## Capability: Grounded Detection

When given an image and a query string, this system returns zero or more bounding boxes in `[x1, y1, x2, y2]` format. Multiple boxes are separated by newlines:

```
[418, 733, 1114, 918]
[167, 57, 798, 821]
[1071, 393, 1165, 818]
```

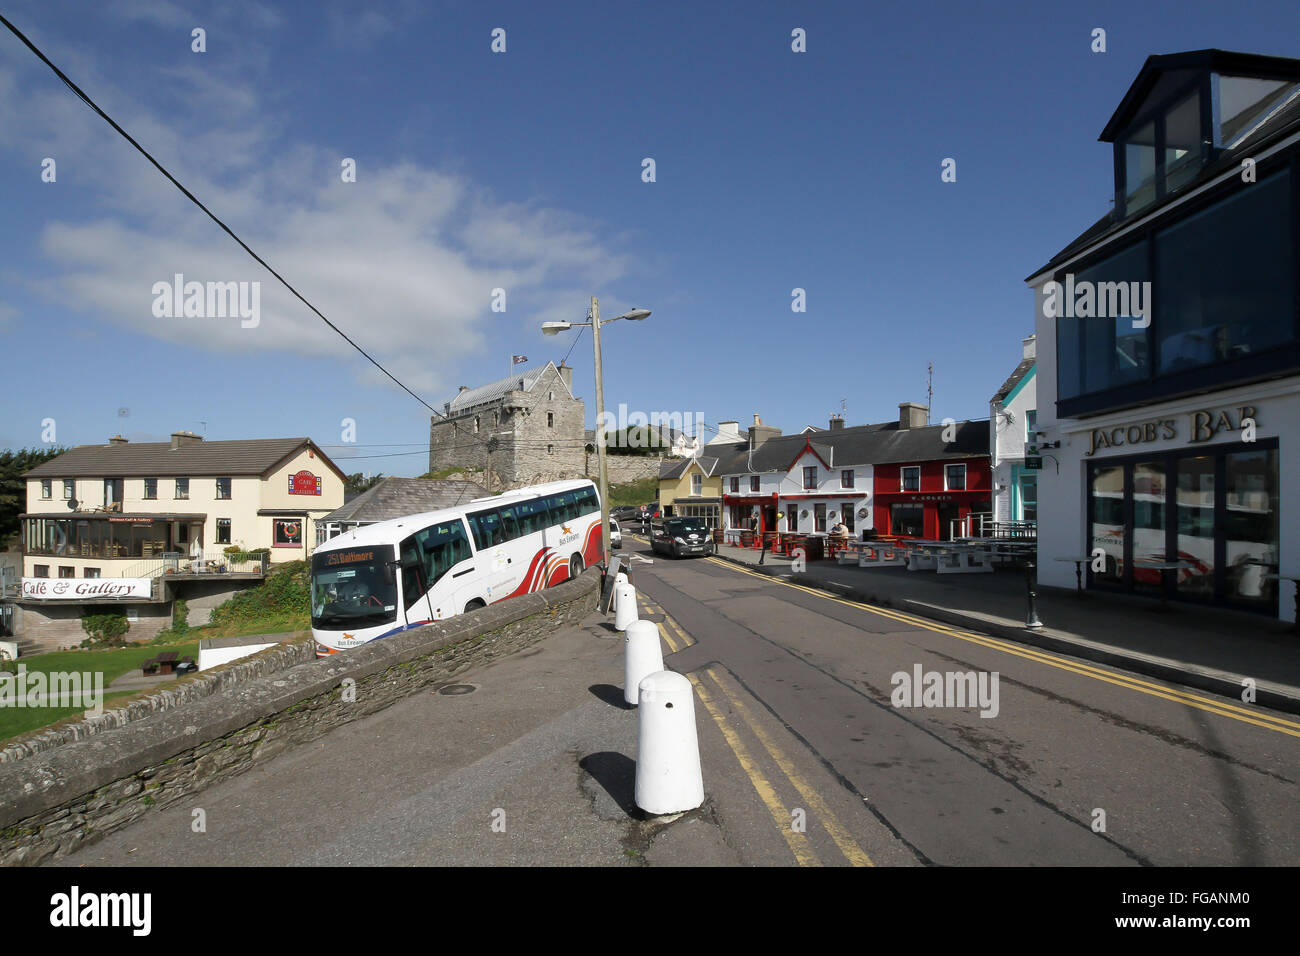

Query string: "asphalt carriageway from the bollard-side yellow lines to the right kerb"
[628, 540, 1300, 866]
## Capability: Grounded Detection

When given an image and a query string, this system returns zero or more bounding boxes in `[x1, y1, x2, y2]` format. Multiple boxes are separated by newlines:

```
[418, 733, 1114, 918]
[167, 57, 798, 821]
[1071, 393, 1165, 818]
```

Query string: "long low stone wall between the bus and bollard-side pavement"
[0, 570, 601, 865]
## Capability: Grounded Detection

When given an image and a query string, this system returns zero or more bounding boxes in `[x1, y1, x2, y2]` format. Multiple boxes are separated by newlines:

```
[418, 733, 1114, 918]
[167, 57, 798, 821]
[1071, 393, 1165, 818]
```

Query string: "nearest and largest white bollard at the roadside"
[636, 671, 705, 814]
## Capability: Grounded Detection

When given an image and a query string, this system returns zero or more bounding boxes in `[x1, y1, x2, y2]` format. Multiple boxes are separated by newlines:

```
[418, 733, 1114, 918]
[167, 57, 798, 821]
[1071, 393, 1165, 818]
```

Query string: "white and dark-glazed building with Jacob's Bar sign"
[1027, 49, 1300, 620]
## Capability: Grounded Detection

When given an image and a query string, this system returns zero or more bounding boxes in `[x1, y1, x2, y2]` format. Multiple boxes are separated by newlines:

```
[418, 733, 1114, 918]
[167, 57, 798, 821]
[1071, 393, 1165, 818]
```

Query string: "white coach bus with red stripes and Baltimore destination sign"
[311, 481, 601, 657]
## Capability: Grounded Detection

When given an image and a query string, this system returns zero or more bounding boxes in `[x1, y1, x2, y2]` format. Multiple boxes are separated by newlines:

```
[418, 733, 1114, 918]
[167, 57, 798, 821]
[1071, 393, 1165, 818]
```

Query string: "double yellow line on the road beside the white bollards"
[641, 598, 872, 866]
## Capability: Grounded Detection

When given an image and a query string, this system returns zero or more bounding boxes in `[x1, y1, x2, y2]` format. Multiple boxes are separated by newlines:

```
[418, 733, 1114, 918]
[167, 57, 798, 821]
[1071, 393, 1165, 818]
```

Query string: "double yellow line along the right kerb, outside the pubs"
[705, 558, 1300, 737]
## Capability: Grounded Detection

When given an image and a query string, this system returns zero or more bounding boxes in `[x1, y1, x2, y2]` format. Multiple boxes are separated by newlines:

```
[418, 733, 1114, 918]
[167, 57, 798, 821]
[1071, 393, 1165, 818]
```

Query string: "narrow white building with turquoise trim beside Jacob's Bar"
[988, 336, 1039, 522]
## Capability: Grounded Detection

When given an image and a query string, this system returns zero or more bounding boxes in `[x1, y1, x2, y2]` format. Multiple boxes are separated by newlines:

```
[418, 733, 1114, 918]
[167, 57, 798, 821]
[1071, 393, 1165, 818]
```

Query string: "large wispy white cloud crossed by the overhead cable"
[0, 42, 625, 395]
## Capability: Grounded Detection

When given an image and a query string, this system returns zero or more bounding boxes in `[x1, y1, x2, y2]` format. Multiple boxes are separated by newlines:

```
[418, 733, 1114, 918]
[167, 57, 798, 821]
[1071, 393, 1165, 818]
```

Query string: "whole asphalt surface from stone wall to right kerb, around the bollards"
[50, 537, 1300, 866]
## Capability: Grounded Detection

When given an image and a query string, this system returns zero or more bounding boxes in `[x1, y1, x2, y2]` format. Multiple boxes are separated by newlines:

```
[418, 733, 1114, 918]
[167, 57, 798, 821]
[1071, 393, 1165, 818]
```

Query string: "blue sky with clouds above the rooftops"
[0, 0, 1300, 475]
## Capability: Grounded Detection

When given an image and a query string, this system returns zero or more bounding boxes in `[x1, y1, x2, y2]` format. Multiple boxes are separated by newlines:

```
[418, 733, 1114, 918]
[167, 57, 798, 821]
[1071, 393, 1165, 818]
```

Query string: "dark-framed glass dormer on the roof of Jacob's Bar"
[1101, 49, 1300, 219]
